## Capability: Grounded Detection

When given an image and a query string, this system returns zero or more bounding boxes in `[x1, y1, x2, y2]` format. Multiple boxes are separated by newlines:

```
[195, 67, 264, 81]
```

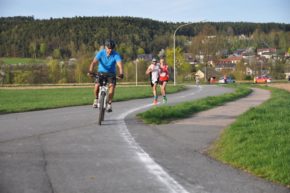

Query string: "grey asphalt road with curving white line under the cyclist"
[0, 86, 289, 193]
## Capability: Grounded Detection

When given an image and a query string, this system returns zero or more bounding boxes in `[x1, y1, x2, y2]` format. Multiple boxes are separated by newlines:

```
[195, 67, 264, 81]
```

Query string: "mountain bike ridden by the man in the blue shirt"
[91, 73, 115, 125]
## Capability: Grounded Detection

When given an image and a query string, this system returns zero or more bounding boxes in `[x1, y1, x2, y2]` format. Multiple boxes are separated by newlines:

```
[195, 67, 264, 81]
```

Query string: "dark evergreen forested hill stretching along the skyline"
[0, 17, 290, 58]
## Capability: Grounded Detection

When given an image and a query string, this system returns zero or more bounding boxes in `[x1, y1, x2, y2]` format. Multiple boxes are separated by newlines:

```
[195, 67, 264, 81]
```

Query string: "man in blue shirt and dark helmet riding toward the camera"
[89, 40, 124, 112]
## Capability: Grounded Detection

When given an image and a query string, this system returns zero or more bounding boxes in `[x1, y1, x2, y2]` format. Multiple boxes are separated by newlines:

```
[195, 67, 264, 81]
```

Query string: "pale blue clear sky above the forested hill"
[0, 0, 290, 24]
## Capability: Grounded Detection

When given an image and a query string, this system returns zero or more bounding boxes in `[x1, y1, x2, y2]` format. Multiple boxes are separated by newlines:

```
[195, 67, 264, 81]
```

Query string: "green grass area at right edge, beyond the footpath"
[209, 88, 290, 187]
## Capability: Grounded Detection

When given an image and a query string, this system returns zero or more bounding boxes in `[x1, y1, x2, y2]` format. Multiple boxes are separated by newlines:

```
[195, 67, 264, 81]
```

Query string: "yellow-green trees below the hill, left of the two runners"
[0, 57, 154, 84]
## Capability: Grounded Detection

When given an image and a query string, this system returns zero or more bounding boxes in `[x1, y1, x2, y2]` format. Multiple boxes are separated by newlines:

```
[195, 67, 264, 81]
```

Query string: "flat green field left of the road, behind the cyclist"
[0, 85, 185, 114]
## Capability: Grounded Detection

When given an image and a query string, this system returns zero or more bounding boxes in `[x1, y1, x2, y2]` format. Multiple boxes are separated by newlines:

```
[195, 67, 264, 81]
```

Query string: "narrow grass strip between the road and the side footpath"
[137, 85, 252, 124]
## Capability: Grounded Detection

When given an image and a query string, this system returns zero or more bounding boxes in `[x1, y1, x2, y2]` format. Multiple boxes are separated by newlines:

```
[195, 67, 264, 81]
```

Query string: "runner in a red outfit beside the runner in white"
[159, 57, 169, 103]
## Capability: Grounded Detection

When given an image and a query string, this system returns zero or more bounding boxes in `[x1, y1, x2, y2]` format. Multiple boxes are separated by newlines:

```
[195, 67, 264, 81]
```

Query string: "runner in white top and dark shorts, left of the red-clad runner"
[146, 58, 160, 105]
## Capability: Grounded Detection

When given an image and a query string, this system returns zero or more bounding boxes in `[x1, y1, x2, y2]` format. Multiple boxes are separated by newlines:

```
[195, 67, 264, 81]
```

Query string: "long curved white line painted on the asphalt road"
[118, 86, 206, 193]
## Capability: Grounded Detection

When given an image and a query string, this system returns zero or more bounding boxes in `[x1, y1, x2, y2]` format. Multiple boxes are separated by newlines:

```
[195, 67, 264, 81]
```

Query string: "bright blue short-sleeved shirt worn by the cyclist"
[96, 49, 122, 74]
